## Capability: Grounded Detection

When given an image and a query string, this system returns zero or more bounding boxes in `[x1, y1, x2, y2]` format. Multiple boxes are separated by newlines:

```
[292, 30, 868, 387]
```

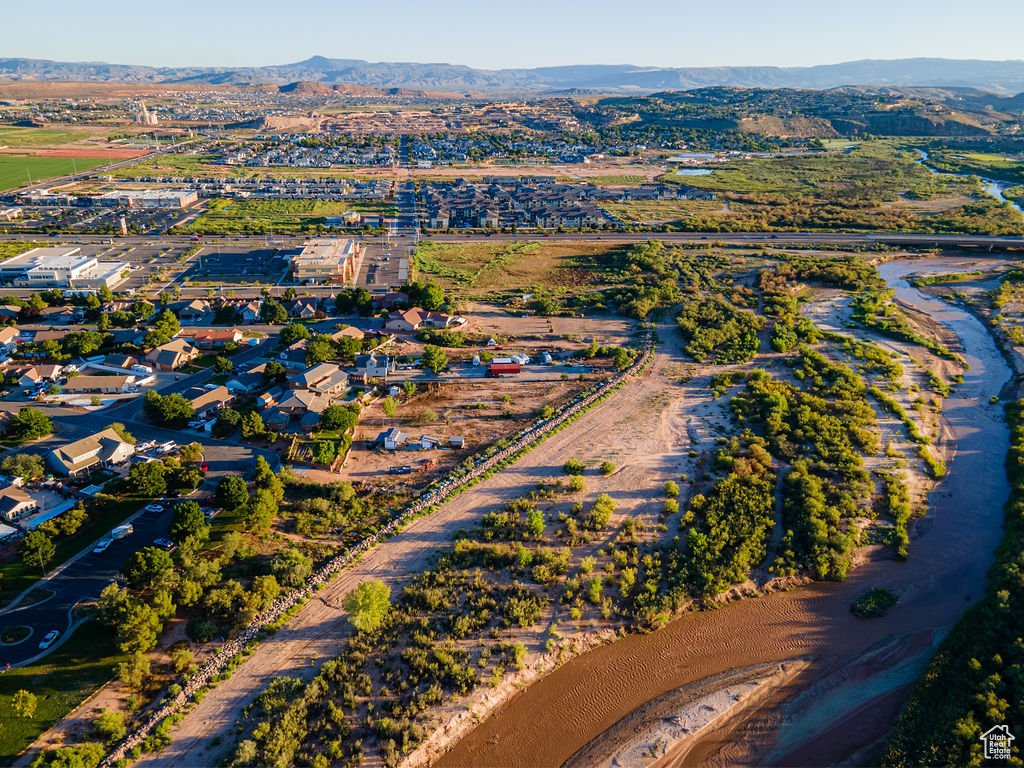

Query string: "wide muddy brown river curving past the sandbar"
[438, 259, 1011, 768]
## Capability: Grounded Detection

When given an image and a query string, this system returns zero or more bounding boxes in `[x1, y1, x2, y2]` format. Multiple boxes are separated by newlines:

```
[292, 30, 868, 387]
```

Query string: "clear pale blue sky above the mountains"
[8, 0, 1024, 69]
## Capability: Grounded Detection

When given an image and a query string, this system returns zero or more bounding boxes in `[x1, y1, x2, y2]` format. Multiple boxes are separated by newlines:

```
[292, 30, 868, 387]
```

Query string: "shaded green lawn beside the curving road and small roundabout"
[0, 621, 124, 765]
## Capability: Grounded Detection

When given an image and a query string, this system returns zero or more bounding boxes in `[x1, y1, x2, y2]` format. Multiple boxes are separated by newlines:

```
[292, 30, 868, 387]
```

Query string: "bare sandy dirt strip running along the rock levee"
[130, 315, 688, 768]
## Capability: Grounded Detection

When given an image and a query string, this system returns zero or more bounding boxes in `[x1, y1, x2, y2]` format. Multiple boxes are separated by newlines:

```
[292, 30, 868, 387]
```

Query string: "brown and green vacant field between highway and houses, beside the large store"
[414, 241, 622, 298]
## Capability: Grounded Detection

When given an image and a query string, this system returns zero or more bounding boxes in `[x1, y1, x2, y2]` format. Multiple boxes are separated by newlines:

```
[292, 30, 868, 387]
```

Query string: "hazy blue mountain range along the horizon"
[0, 56, 1024, 94]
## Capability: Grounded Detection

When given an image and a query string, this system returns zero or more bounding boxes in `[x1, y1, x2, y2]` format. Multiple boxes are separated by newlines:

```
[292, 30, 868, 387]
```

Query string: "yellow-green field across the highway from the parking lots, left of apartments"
[184, 200, 394, 234]
